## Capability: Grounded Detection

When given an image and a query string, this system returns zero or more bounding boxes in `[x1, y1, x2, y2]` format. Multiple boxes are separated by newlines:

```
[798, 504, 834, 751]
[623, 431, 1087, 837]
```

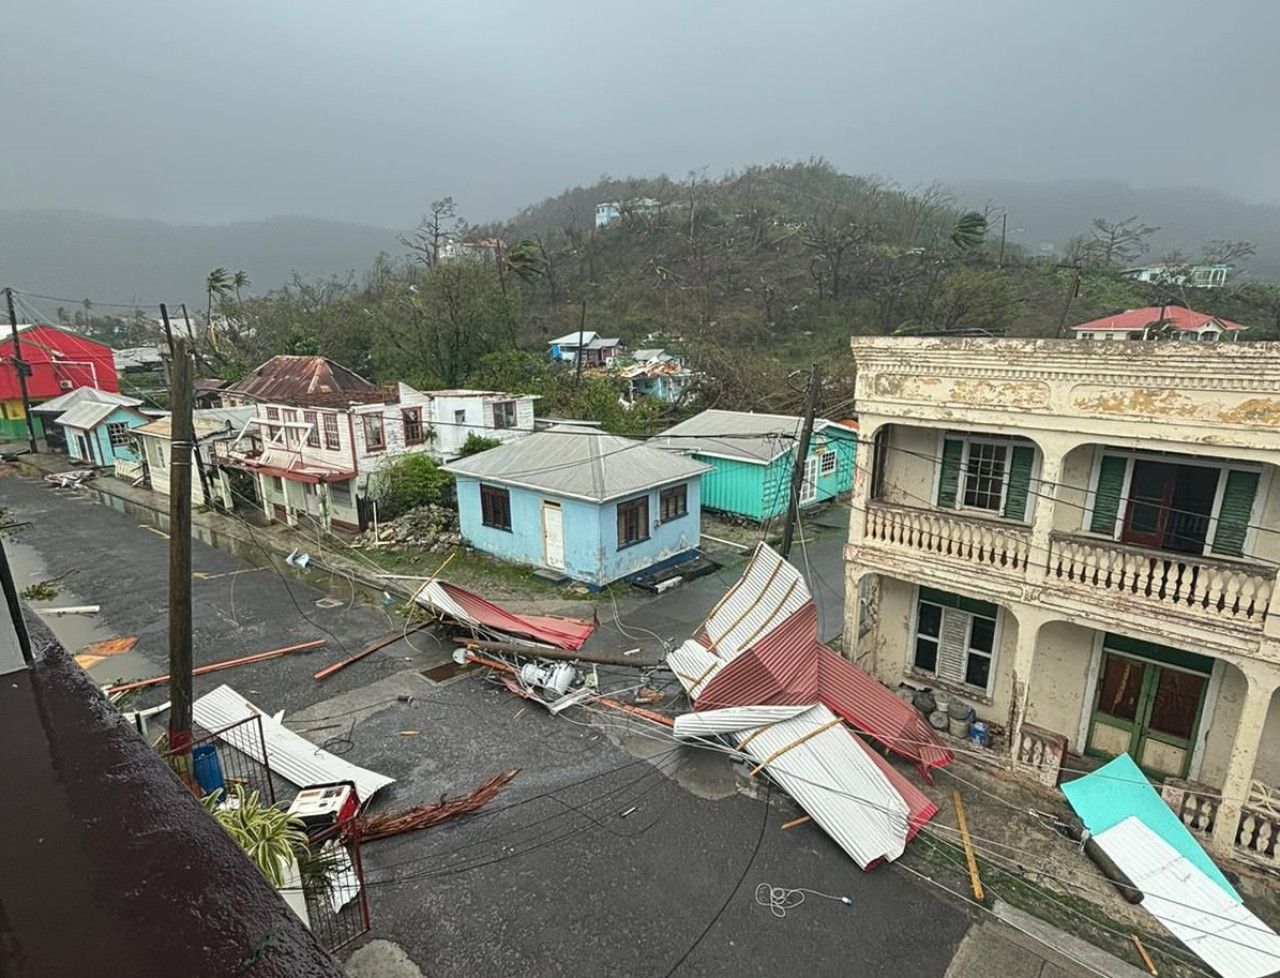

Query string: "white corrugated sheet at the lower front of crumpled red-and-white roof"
[677, 704, 911, 869]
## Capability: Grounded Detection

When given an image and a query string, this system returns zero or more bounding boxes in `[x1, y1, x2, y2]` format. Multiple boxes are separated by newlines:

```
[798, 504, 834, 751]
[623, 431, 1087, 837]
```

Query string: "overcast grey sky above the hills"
[0, 0, 1280, 227]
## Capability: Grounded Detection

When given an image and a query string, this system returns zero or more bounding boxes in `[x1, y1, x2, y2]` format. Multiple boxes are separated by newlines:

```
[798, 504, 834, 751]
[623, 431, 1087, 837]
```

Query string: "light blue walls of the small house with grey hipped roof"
[457, 477, 701, 586]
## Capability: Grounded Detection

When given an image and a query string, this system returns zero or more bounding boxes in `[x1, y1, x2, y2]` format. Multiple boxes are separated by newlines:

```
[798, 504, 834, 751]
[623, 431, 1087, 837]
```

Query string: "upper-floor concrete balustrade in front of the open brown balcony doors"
[1047, 534, 1276, 630]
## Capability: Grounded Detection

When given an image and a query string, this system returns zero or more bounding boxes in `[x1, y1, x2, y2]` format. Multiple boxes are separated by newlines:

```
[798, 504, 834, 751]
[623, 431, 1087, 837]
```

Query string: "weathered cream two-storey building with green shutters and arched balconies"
[845, 337, 1280, 869]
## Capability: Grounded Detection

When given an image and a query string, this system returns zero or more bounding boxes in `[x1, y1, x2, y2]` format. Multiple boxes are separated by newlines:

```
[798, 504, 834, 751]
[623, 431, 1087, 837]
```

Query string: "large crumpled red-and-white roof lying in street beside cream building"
[667, 544, 952, 869]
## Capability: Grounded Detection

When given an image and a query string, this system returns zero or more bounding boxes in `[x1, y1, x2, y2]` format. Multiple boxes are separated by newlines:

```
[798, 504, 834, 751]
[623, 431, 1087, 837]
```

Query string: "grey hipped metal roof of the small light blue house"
[444, 425, 710, 503]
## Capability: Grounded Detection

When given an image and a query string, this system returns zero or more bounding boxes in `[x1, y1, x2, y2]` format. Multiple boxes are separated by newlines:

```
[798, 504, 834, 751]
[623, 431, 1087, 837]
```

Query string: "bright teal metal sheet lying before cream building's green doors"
[1062, 754, 1242, 902]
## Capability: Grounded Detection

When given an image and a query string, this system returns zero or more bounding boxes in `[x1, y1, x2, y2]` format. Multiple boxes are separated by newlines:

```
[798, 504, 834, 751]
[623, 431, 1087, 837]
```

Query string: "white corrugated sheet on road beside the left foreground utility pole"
[191, 686, 396, 803]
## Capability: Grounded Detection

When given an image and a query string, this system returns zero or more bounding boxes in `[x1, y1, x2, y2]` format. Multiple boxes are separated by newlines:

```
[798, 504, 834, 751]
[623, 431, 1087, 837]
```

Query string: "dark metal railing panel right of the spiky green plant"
[302, 826, 371, 954]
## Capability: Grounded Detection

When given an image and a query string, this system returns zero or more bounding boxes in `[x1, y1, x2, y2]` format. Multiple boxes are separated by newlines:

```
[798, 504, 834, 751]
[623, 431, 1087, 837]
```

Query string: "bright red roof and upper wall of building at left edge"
[0, 325, 120, 401]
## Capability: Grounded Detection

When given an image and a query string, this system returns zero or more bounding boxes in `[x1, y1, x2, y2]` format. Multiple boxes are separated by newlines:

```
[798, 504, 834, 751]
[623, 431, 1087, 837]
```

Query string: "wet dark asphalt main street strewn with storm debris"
[0, 475, 968, 978]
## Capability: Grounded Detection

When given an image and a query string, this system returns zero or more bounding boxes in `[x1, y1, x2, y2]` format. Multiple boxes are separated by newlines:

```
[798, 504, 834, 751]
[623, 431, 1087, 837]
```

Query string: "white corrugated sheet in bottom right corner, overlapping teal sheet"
[1096, 815, 1280, 978]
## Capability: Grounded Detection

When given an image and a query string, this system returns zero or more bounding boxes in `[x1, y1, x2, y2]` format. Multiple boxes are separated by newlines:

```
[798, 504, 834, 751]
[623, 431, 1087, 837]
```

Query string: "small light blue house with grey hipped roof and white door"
[444, 425, 710, 588]
